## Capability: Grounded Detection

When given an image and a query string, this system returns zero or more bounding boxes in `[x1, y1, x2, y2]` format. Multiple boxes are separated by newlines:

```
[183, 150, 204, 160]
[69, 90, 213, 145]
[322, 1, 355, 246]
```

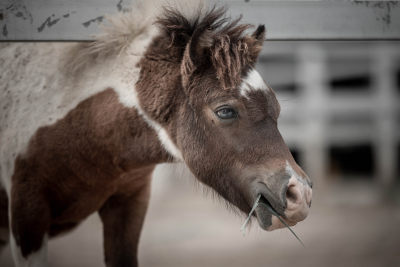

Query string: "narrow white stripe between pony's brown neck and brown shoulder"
[114, 85, 183, 161]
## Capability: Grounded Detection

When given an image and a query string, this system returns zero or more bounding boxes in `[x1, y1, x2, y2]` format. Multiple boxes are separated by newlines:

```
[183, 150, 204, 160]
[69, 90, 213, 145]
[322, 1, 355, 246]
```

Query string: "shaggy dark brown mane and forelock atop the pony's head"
[156, 6, 264, 88]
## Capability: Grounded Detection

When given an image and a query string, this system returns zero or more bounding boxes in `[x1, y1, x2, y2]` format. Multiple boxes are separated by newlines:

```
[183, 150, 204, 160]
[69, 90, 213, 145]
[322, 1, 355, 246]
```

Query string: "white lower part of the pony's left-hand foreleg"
[10, 234, 48, 267]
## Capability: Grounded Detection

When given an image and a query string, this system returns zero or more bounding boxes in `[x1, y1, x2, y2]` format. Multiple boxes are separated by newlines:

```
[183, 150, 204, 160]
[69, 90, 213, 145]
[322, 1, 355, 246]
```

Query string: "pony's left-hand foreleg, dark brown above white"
[10, 184, 50, 267]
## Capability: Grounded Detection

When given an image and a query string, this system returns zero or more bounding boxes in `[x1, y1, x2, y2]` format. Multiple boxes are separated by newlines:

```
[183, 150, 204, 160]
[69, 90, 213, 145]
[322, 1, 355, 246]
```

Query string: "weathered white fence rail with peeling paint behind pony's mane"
[0, 0, 400, 41]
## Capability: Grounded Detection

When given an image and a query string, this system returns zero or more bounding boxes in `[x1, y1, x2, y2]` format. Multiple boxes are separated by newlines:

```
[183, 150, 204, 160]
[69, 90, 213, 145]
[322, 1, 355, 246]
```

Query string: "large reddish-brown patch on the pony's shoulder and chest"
[11, 89, 168, 256]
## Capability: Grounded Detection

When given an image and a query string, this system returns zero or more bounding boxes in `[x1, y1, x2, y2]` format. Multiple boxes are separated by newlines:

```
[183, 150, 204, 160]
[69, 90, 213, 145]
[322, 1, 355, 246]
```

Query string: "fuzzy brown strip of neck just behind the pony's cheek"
[135, 34, 185, 160]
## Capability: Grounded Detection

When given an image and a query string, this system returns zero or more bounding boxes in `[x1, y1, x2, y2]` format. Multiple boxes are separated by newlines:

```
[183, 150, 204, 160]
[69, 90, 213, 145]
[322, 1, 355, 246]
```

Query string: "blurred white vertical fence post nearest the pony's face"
[295, 44, 328, 191]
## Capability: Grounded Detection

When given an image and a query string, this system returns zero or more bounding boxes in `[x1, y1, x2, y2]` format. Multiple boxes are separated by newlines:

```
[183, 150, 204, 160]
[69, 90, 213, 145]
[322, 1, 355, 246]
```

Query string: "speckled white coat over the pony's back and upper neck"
[0, 25, 164, 196]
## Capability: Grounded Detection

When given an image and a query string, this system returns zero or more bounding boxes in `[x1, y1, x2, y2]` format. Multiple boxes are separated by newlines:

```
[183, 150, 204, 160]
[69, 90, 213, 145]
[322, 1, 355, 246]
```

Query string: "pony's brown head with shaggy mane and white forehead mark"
[138, 8, 312, 230]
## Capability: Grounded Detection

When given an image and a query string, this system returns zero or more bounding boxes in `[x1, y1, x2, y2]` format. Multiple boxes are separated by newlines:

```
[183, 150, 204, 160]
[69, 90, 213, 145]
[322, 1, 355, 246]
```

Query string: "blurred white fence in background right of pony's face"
[258, 42, 400, 184]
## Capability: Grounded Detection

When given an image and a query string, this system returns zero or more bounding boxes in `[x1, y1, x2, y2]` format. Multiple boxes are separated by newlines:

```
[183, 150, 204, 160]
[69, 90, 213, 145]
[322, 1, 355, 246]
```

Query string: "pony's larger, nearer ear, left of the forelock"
[181, 29, 213, 88]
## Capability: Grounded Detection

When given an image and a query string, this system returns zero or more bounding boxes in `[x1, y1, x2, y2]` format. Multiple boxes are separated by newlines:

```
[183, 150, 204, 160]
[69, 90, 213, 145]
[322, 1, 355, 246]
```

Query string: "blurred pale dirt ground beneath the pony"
[0, 166, 400, 267]
